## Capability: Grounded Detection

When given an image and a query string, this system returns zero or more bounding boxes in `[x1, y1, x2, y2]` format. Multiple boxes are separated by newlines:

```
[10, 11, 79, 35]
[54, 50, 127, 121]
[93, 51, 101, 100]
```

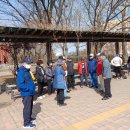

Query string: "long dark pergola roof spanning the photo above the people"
[0, 26, 130, 43]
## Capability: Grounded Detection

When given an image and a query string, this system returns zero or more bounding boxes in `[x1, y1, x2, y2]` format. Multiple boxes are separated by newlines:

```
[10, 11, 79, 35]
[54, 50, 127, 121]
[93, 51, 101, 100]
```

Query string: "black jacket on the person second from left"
[35, 65, 45, 82]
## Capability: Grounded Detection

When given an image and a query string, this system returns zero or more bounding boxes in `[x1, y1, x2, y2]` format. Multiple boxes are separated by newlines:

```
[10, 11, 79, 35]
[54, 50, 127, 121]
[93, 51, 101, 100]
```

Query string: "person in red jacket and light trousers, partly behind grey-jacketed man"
[97, 53, 105, 94]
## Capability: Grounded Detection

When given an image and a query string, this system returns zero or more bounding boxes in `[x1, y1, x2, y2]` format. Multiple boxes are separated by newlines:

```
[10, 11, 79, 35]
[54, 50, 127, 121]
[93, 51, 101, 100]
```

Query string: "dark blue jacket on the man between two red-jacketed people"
[88, 58, 98, 74]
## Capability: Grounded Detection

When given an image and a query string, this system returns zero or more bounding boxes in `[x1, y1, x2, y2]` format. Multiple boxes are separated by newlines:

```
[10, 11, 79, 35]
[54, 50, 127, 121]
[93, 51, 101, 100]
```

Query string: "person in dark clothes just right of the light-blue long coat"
[66, 57, 76, 92]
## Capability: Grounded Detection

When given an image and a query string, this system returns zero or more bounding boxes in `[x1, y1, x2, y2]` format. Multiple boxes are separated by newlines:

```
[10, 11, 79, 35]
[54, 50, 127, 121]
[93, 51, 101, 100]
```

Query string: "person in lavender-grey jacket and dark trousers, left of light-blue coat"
[45, 61, 54, 95]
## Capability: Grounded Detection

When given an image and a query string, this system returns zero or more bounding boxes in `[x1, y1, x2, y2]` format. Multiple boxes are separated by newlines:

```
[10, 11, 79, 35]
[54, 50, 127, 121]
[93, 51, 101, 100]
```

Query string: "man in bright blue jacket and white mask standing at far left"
[17, 57, 36, 128]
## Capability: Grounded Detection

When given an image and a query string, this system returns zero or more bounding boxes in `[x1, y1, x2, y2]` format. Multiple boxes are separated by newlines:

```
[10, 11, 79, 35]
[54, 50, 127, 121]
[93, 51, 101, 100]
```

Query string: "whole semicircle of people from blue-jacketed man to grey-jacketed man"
[17, 52, 112, 128]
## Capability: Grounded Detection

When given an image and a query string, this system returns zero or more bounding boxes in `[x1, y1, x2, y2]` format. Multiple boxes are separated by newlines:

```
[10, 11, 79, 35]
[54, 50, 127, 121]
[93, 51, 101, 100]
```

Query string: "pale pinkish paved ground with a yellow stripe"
[0, 77, 130, 130]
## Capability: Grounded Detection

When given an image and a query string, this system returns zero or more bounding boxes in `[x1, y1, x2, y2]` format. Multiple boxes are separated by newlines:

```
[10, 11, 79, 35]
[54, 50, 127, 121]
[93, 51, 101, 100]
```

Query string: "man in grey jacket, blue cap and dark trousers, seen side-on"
[100, 52, 112, 100]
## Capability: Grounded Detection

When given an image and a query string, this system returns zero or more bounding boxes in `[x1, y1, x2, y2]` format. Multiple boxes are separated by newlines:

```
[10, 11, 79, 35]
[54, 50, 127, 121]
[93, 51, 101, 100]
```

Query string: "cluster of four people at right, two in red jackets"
[78, 53, 112, 100]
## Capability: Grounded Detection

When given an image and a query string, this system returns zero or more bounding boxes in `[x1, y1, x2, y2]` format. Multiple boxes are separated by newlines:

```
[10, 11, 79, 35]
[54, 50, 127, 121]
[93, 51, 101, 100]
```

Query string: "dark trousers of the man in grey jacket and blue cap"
[104, 78, 112, 97]
